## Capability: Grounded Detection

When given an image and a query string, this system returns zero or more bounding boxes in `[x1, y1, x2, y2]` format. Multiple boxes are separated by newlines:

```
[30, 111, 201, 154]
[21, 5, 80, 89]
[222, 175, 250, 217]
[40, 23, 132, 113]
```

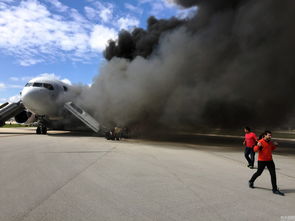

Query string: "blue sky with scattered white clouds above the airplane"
[0, 0, 198, 103]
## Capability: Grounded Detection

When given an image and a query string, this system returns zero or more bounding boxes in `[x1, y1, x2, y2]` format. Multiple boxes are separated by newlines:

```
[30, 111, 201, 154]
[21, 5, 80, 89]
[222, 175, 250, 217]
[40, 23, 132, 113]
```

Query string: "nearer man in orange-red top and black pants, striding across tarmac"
[249, 131, 285, 196]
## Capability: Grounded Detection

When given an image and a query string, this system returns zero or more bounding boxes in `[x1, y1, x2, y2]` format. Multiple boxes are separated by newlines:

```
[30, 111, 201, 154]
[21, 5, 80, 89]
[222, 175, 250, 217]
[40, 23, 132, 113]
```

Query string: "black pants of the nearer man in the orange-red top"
[249, 161, 278, 190]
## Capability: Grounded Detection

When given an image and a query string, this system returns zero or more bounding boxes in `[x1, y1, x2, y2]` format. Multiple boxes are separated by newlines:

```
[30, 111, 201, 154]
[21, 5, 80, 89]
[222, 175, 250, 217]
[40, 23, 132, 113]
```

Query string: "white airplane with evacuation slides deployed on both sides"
[0, 77, 101, 134]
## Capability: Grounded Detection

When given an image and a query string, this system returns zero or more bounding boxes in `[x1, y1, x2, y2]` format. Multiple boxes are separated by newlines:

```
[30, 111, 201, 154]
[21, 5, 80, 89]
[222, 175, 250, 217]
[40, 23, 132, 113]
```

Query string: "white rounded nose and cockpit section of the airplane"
[21, 77, 70, 117]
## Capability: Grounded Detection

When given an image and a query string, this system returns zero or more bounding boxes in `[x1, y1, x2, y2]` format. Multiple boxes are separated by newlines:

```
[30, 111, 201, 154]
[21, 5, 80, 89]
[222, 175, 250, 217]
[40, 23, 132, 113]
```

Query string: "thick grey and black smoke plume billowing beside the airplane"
[80, 0, 295, 128]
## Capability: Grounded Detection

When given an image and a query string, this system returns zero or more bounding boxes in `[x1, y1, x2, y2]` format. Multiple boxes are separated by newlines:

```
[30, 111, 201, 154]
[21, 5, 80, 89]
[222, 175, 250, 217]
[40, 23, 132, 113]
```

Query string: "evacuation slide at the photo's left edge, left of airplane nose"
[0, 101, 25, 126]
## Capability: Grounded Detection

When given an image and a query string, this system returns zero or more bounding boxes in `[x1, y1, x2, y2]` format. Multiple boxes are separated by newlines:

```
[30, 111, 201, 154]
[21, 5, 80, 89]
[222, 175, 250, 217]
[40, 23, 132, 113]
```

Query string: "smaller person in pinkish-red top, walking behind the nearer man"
[243, 127, 257, 169]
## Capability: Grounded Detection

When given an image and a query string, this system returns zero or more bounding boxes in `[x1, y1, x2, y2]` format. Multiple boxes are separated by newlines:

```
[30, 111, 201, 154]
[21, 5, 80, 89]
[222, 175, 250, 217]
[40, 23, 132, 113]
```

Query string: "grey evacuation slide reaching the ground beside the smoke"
[64, 101, 100, 133]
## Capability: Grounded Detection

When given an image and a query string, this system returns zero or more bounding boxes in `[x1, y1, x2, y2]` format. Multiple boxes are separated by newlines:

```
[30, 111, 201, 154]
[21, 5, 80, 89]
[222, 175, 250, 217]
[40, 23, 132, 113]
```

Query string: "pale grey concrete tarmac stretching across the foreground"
[0, 128, 295, 221]
